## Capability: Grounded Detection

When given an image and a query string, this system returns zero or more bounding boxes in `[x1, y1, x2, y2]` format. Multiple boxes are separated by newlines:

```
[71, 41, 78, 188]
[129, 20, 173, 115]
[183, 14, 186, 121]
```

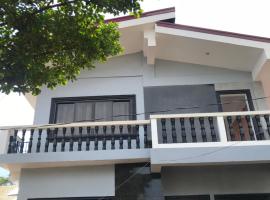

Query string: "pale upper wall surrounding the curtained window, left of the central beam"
[34, 54, 144, 124]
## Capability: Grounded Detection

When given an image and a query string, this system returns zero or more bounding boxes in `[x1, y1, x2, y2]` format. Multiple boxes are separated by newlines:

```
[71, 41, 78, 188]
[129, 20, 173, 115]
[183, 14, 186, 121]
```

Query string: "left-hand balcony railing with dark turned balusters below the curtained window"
[1, 120, 151, 154]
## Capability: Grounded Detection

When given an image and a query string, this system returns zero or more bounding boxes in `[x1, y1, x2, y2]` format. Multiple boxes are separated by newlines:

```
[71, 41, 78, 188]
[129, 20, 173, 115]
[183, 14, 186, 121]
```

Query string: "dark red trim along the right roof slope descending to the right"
[157, 22, 270, 43]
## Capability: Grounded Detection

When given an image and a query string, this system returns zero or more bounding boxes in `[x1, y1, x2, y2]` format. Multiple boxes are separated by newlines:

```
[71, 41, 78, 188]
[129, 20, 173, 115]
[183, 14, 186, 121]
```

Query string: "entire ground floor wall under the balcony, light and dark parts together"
[18, 163, 270, 200]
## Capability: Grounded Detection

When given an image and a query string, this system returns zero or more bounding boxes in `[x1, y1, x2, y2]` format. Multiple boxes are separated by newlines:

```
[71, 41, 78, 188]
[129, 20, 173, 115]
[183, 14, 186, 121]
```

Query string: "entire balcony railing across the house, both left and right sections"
[0, 111, 270, 154]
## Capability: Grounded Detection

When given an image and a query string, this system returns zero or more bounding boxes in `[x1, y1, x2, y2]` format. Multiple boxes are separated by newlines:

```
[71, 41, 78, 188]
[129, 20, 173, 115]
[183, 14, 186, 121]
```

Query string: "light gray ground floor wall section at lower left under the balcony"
[18, 165, 115, 200]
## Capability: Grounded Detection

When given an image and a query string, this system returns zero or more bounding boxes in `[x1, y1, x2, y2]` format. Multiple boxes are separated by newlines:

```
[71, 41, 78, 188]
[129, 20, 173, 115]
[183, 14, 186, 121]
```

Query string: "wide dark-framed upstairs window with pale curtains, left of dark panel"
[50, 95, 136, 123]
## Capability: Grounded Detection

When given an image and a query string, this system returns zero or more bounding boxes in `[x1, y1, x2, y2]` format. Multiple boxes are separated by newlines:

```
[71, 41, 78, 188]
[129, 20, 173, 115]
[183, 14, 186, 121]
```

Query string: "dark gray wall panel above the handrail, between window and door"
[144, 85, 218, 117]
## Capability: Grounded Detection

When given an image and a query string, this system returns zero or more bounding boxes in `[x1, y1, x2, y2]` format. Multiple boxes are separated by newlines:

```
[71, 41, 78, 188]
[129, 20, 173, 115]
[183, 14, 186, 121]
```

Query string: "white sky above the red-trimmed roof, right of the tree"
[142, 0, 270, 37]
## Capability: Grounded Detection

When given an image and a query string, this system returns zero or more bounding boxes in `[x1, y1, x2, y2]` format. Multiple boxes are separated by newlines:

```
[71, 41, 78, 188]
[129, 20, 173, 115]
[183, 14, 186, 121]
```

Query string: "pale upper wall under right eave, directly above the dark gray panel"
[144, 60, 252, 86]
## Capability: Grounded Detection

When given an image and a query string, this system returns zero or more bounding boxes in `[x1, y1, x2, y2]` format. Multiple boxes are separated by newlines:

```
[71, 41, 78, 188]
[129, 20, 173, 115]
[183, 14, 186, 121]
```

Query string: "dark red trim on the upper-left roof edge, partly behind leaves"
[105, 7, 175, 22]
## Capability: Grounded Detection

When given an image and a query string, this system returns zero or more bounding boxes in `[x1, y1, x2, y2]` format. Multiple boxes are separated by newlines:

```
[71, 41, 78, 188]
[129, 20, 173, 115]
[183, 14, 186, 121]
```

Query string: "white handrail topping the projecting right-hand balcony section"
[150, 110, 270, 119]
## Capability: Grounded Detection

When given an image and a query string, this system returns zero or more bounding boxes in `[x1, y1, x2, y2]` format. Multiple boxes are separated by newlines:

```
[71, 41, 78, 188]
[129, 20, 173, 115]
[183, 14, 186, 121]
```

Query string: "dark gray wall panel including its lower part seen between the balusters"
[144, 85, 219, 143]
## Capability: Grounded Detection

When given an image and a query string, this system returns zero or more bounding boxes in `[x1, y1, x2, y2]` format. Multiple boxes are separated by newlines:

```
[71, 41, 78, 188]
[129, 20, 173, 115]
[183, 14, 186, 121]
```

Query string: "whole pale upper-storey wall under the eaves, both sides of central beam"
[34, 53, 266, 124]
